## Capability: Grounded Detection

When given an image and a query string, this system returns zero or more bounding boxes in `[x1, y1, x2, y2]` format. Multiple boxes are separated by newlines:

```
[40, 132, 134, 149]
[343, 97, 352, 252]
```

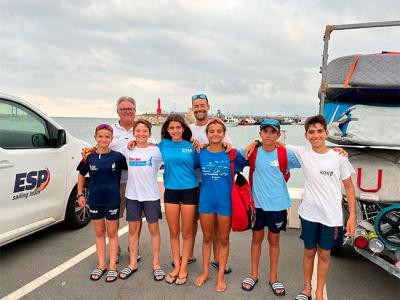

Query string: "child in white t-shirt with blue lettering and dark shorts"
[119, 120, 165, 281]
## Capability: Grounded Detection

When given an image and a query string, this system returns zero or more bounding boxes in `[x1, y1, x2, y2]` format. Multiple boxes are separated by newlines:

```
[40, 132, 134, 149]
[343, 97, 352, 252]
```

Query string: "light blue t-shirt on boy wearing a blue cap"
[241, 147, 300, 211]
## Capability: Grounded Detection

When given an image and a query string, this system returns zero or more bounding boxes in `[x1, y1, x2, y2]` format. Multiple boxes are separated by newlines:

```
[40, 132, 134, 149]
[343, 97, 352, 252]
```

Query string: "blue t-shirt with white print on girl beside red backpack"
[198, 148, 247, 212]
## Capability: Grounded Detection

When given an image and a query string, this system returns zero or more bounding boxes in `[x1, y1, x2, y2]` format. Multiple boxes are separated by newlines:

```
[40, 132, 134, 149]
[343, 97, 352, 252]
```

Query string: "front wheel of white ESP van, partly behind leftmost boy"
[65, 184, 90, 229]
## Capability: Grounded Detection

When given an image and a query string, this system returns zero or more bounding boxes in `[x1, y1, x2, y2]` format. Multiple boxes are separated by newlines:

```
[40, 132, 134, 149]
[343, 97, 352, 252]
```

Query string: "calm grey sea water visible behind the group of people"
[53, 117, 309, 188]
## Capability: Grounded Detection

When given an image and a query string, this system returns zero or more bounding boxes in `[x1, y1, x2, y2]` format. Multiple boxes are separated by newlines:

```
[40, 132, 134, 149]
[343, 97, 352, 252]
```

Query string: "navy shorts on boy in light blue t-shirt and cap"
[253, 208, 287, 233]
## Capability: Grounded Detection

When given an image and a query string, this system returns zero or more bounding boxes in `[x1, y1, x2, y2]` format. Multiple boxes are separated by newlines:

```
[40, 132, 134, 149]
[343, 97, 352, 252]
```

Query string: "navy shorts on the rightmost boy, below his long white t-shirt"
[300, 218, 343, 250]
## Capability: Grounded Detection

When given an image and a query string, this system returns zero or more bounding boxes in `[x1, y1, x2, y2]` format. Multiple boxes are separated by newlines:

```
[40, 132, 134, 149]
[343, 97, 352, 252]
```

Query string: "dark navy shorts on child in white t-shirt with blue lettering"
[126, 198, 162, 224]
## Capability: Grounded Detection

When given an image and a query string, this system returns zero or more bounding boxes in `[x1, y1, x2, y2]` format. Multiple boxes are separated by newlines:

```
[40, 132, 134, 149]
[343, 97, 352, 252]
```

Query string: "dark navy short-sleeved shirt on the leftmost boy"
[76, 150, 128, 207]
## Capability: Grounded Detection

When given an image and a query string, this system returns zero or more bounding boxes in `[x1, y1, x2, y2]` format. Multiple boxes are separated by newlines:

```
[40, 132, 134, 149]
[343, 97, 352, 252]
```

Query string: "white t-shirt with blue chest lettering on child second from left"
[119, 146, 163, 201]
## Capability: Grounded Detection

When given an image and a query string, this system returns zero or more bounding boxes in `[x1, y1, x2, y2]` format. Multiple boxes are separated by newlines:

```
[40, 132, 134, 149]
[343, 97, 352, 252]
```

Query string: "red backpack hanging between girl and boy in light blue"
[228, 149, 256, 231]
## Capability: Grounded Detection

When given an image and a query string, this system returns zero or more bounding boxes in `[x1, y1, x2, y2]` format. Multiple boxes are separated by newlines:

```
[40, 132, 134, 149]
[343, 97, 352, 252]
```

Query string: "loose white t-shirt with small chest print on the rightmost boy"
[286, 145, 355, 227]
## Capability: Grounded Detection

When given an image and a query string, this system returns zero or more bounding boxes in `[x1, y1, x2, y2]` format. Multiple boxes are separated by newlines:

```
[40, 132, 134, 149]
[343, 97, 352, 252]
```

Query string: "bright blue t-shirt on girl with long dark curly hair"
[157, 139, 198, 190]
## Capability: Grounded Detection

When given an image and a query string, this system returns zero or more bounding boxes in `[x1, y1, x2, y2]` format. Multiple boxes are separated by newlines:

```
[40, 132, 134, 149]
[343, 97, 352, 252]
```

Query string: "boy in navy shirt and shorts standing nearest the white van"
[77, 124, 127, 282]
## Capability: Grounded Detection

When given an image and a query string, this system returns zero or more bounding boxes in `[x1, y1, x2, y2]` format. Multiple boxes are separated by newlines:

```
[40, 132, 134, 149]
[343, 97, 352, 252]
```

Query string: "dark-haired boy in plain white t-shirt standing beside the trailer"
[286, 115, 356, 300]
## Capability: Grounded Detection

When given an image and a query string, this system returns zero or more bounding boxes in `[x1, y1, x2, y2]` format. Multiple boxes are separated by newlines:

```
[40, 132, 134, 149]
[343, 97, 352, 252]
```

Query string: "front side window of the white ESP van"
[0, 99, 50, 149]
